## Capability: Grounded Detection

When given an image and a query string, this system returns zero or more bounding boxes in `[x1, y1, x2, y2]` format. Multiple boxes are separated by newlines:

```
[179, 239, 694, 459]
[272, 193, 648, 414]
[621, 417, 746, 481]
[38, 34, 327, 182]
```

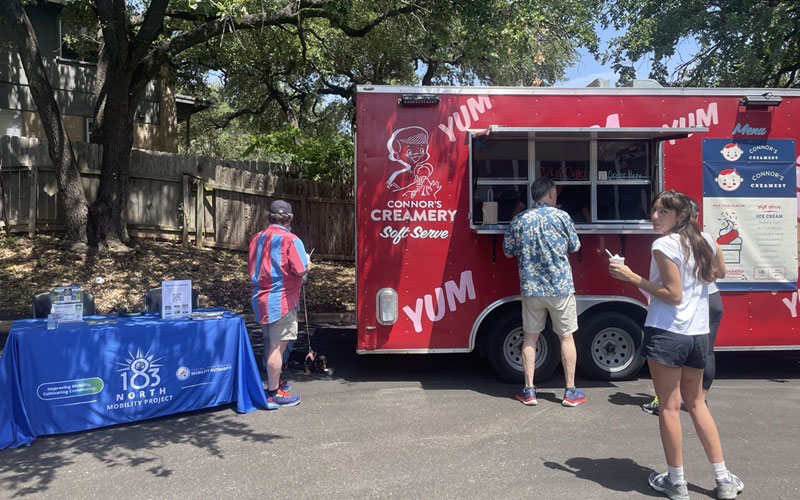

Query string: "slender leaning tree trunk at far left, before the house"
[0, 0, 87, 243]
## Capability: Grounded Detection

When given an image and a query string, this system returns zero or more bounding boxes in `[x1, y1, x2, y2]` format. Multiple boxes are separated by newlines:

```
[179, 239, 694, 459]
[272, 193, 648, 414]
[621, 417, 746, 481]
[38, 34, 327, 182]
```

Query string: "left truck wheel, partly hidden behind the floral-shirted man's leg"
[488, 314, 561, 383]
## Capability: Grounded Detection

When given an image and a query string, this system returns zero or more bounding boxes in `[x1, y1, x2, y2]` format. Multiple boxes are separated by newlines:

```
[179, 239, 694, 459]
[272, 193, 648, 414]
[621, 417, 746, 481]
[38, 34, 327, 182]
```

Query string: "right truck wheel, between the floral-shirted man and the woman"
[576, 312, 644, 380]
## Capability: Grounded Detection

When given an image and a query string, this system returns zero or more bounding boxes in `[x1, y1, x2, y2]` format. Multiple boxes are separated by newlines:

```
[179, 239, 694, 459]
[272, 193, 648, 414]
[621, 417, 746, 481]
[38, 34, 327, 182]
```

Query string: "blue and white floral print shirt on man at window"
[503, 202, 581, 297]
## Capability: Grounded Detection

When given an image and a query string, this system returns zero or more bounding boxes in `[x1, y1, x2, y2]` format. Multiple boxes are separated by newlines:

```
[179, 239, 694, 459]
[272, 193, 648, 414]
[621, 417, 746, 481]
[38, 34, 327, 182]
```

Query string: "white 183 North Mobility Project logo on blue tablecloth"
[106, 349, 172, 410]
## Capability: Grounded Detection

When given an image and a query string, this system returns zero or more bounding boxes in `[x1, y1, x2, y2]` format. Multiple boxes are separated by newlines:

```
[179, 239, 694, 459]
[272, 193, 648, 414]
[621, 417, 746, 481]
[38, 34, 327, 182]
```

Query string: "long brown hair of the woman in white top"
[651, 189, 714, 283]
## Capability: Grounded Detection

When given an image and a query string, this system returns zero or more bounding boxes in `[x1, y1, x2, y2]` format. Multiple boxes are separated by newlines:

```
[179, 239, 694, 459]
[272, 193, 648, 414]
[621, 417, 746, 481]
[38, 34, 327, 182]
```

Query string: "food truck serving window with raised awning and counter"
[470, 126, 708, 231]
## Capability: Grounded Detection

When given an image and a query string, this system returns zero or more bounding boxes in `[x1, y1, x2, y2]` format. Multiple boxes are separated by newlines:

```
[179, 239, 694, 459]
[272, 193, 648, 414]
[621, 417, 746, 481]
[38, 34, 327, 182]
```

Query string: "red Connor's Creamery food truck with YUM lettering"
[355, 81, 800, 382]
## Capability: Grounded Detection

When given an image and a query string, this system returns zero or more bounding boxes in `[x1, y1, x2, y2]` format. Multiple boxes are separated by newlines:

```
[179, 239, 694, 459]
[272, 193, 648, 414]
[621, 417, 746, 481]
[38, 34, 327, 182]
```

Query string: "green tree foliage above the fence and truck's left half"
[174, 0, 597, 179]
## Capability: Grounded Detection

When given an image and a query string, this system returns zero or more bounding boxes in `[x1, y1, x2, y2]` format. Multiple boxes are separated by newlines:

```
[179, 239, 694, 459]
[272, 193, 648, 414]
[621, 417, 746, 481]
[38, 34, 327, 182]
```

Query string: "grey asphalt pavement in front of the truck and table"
[0, 327, 800, 500]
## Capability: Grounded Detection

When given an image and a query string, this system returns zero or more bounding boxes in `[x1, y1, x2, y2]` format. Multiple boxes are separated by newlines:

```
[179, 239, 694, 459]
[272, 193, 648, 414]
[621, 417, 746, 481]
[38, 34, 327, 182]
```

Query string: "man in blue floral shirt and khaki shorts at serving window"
[503, 178, 586, 406]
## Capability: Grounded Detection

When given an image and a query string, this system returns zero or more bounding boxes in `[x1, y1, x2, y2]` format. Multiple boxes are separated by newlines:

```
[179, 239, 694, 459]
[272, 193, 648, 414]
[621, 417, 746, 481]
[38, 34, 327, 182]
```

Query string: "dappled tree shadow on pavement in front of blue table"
[0, 405, 282, 498]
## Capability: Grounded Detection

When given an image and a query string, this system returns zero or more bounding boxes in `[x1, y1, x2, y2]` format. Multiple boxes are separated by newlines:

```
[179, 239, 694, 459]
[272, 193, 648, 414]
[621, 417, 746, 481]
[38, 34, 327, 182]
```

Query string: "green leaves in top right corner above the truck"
[602, 0, 800, 87]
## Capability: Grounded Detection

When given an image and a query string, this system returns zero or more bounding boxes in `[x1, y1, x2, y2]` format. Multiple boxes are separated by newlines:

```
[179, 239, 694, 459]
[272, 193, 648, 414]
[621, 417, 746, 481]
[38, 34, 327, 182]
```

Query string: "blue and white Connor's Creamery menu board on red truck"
[703, 139, 797, 290]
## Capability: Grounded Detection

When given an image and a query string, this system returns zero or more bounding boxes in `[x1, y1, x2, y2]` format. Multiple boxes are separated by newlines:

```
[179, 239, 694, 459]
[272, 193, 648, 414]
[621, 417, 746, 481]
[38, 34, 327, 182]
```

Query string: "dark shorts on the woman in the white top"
[642, 326, 708, 369]
